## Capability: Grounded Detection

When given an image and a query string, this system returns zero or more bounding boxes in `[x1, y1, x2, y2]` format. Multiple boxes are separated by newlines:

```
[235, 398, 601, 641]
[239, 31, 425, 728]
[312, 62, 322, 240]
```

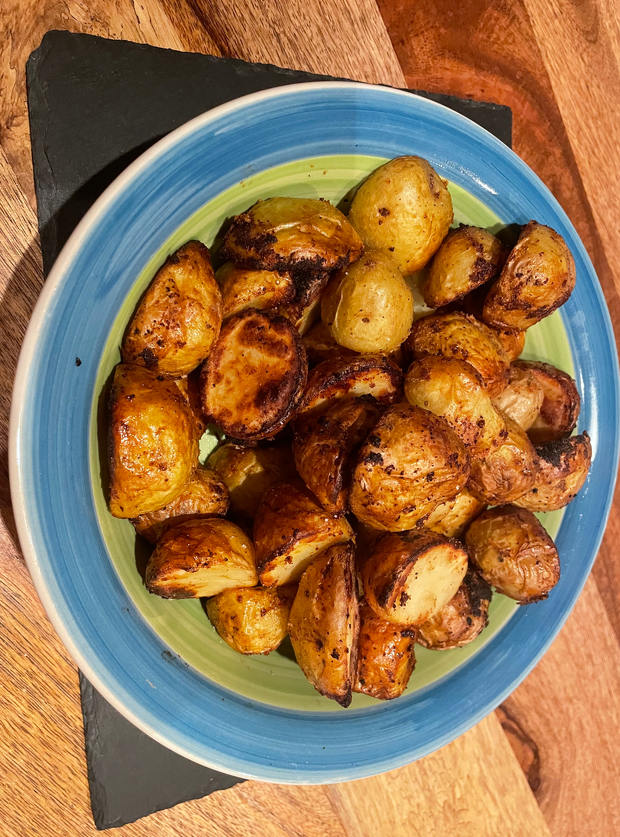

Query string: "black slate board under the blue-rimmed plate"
[27, 32, 512, 829]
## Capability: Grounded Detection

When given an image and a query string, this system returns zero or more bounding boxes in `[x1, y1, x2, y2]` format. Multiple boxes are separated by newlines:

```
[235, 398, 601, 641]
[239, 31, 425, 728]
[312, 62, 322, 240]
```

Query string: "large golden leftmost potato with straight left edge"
[108, 363, 198, 517]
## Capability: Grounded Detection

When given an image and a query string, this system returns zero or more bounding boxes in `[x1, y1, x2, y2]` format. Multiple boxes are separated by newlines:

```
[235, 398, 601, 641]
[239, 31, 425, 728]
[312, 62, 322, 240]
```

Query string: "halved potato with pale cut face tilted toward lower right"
[362, 529, 467, 626]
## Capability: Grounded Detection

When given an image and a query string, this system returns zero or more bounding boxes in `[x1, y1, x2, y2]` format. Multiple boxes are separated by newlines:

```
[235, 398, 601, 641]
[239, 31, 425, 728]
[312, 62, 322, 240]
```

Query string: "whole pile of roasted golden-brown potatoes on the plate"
[108, 157, 591, 706]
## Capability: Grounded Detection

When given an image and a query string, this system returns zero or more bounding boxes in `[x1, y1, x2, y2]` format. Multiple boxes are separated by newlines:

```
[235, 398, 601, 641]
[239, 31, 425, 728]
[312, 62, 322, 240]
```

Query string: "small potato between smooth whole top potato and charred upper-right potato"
[423, 224, 505, 308]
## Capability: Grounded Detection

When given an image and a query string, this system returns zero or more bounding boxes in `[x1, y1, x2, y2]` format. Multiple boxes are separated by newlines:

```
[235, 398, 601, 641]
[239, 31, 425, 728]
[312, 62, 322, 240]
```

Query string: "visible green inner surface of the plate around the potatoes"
[90, 155, 573, 712]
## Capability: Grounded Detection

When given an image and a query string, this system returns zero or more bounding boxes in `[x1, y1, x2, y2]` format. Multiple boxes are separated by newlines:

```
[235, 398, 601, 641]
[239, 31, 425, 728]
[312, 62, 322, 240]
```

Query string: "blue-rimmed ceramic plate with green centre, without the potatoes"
[10, 82, 620, 783]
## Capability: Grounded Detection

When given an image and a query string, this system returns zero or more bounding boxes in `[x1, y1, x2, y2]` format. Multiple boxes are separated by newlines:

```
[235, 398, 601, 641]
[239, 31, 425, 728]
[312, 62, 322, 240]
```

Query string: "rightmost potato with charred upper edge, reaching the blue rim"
[514, 433, 592, 511]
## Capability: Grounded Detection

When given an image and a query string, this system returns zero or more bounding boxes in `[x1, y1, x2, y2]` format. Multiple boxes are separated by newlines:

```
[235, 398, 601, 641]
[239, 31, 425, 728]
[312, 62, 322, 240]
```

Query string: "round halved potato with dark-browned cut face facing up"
[201, 309, 308, 440]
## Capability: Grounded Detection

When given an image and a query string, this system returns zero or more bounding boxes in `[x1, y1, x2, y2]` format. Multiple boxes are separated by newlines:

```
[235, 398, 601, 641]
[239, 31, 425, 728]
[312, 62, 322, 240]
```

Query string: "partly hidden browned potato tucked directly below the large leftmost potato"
[131, 468, 229, 543]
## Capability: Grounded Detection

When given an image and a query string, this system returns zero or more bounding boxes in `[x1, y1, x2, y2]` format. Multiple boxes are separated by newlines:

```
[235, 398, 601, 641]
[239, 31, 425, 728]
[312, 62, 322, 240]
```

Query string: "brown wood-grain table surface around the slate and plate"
[0, 0, 620, 837]
